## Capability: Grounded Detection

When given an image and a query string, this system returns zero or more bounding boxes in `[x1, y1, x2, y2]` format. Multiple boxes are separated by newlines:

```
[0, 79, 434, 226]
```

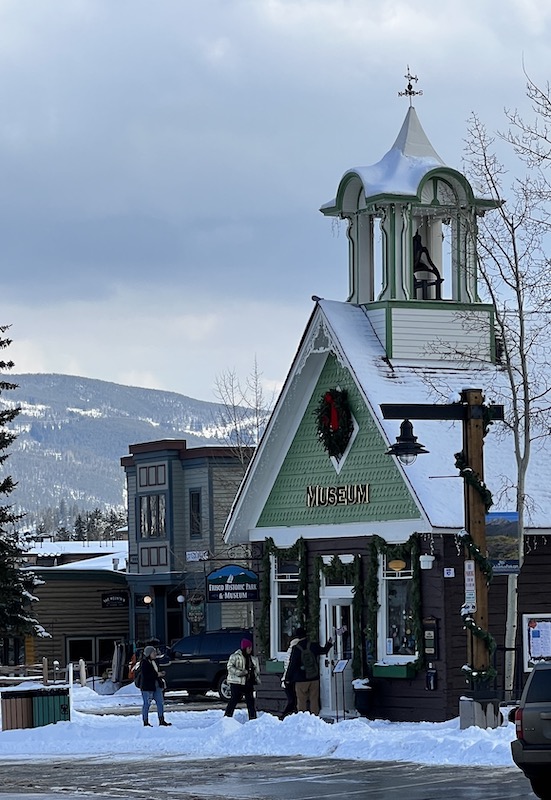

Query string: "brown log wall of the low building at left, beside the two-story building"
[33, 574, 129, 667]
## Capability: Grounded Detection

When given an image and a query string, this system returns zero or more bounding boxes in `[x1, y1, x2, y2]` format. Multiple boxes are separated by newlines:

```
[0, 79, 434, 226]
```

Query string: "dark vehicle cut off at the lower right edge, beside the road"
[511, 662, 551, 800]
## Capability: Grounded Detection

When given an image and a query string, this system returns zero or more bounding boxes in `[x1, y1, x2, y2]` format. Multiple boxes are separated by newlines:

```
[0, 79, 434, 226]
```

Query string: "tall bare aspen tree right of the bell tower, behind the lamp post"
[466, 82, 551, 692]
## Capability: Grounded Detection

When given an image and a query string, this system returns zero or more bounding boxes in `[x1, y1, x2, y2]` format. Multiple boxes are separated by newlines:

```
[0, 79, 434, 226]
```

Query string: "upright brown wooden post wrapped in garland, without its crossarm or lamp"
[462, 389, 490, 671]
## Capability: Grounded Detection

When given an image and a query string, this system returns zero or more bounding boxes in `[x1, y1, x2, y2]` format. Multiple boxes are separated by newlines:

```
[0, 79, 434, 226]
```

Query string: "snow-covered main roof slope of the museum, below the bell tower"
[319, 300, 551, 529]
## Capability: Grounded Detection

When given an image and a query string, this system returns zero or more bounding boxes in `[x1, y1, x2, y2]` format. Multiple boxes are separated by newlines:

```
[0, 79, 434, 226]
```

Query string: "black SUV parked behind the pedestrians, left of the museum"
[159, 628, 253, 700]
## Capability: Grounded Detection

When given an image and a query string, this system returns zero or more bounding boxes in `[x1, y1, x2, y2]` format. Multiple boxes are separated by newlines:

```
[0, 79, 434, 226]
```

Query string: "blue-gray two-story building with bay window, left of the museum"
[121, 439, 252, 644]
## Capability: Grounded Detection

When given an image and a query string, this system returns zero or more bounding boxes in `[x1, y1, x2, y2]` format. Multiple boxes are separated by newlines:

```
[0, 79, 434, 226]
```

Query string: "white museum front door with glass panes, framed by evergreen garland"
[320, 586, 354, 719]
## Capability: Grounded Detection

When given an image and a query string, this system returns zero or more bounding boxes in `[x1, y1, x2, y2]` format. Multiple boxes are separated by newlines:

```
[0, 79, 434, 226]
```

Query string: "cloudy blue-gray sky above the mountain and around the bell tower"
[4, 0, 551, 400]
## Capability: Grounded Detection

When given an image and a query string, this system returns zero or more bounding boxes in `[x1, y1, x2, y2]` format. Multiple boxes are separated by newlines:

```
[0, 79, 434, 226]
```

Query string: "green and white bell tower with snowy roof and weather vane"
[320, 72, 495, 362]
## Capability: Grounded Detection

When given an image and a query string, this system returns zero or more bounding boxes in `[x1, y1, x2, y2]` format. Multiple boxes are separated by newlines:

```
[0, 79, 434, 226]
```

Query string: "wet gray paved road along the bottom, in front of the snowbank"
[0, 754, 534, 800]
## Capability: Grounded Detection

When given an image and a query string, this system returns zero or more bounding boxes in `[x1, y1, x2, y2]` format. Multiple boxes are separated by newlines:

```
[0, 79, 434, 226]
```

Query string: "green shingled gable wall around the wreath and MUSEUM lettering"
[257, 355, 420, 528]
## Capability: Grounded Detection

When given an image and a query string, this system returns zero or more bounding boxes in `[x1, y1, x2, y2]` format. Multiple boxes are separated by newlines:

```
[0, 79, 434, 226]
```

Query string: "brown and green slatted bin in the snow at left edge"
[0, 686, 71, 731]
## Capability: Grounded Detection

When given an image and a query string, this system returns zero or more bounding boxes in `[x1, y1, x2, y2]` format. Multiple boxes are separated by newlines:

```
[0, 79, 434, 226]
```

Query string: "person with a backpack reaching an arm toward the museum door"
[285, 628, 333, 715]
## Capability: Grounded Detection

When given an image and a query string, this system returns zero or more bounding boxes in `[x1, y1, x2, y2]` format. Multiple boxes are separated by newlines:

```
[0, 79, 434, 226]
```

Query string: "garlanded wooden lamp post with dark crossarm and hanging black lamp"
[381, 389, 503, 672]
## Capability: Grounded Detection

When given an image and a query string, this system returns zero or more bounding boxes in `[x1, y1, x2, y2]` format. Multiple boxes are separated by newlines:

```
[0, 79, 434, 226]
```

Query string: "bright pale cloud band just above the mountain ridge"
[4, 287, 312, 400]
